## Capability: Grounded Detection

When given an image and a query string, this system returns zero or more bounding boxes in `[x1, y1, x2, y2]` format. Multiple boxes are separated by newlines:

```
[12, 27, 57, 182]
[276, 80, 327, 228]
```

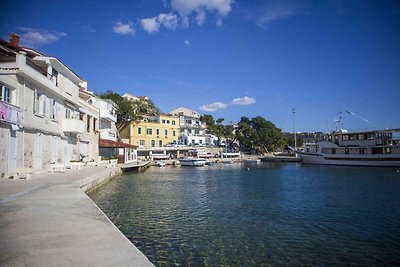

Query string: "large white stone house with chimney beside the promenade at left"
[0, 34, 96, 177]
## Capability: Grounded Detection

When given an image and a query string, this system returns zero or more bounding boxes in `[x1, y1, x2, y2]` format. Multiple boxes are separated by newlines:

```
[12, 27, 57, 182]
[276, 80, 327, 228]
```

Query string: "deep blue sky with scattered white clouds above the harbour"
[0, 0, 400, 132]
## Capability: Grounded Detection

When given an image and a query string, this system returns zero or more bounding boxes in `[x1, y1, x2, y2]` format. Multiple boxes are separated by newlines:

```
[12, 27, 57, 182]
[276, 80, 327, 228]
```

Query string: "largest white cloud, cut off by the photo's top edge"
[171, 0, 234, 27]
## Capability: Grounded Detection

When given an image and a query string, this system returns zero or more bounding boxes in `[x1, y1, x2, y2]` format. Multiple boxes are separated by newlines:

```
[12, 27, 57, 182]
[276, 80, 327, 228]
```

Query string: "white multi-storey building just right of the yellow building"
[169, 107, 214, 145]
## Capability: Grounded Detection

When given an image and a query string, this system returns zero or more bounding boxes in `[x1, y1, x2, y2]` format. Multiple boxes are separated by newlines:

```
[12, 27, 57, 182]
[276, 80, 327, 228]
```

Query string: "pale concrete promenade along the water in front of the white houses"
[0, 167, 153, 266]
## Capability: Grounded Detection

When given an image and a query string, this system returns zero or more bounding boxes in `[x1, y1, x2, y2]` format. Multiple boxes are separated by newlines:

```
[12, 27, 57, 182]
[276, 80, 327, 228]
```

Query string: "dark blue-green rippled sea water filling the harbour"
[90, 163, 400, 266]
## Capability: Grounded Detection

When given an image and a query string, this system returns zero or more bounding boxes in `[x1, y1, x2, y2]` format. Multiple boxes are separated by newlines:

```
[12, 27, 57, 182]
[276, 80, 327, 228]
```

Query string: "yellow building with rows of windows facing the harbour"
[120, 115, 179, 148]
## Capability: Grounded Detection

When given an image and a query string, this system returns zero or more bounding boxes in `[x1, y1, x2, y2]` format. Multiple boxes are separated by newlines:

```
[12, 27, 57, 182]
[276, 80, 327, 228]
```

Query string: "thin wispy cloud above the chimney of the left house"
[19, 27, 67, 48]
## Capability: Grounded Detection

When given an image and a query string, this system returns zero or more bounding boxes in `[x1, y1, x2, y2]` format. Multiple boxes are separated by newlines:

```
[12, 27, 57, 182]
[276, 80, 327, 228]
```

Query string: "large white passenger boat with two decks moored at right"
[296, 129, 400, 167]
